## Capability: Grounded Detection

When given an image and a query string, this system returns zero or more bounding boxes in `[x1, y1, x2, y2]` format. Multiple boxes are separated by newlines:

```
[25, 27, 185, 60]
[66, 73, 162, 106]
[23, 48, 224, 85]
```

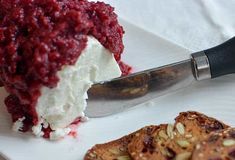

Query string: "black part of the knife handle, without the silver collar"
[204, 37, 235, 78]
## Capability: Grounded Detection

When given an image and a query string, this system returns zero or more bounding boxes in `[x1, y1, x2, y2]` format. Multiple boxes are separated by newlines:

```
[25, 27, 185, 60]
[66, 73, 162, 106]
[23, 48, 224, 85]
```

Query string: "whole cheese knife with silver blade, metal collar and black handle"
[85, 37, 235, 118]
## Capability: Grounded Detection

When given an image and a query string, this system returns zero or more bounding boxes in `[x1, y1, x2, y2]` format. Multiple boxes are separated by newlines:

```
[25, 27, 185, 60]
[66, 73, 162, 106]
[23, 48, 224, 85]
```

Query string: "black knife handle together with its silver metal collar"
[191, 37, 235, 80]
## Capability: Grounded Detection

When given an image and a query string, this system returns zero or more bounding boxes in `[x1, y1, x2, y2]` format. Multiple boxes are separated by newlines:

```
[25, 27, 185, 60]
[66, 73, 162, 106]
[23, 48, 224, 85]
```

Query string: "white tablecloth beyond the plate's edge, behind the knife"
[105, 0, 235, 51]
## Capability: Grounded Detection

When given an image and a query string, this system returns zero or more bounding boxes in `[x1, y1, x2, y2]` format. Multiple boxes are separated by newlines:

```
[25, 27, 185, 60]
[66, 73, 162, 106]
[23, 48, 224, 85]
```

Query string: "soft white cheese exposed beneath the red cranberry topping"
[33, 37, 121, 139]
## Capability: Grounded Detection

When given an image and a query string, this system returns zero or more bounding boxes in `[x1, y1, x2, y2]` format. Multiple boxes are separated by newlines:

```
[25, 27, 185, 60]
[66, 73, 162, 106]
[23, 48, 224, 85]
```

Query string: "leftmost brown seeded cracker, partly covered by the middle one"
[84, 129, 149, 160]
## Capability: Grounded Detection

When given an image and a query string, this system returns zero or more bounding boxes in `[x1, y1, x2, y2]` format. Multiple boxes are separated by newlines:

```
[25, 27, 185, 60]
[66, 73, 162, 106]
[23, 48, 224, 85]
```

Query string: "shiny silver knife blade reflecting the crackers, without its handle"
[85, 59, 196, 118]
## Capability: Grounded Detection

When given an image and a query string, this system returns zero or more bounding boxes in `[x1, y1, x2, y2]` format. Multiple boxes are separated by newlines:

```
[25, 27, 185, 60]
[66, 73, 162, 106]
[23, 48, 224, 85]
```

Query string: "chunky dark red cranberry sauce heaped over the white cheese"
[0, 0, 126, 131]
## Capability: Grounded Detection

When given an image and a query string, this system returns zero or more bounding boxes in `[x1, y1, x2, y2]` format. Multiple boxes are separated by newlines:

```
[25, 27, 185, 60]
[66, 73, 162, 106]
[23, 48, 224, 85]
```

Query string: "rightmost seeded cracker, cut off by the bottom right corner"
[192, 128, 235, 160]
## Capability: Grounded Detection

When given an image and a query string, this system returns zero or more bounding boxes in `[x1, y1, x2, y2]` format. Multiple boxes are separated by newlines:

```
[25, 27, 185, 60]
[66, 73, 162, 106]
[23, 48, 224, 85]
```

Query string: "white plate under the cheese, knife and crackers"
[0, 21, 235, 160]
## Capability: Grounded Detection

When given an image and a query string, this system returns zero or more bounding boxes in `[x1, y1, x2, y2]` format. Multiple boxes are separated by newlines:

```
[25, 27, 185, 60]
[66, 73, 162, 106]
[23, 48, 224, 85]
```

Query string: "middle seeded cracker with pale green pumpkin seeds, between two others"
[128, 112, 228, 160]
